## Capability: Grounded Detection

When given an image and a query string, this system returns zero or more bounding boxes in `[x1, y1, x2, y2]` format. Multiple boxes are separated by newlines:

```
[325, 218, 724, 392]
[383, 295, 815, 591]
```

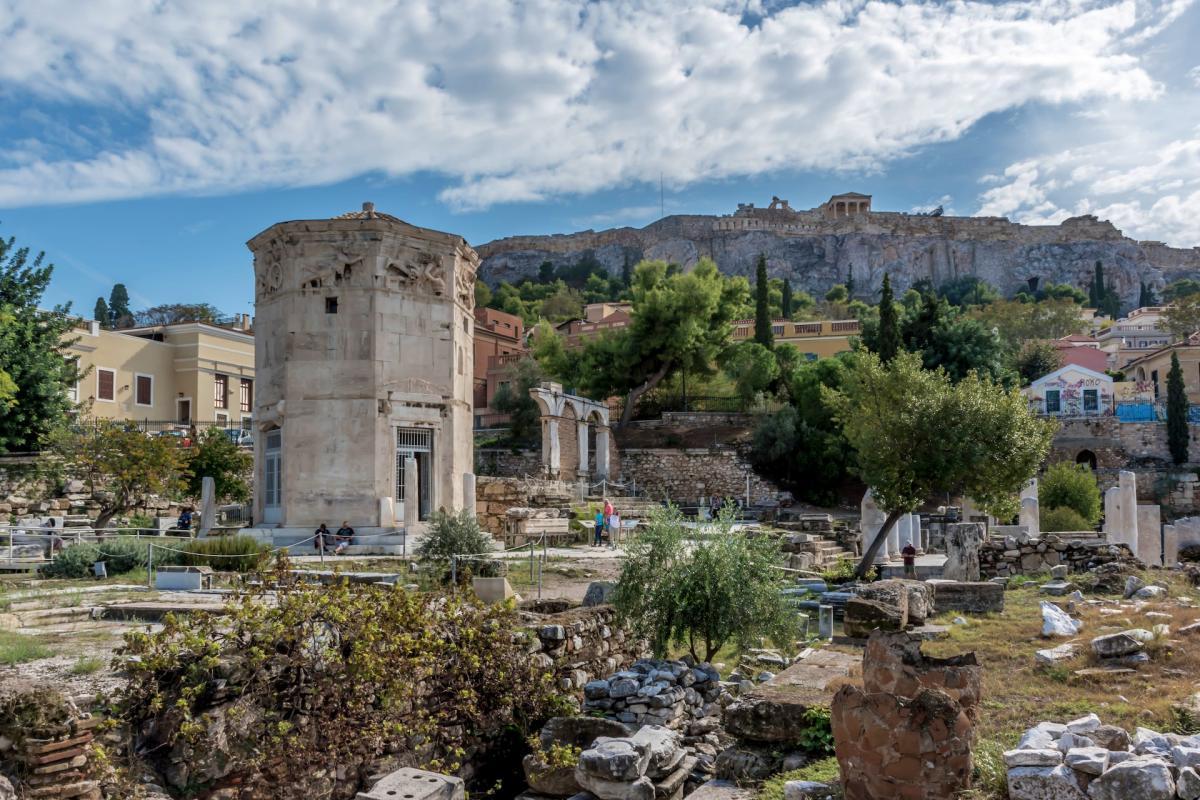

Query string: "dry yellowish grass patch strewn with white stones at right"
[925, 573, 1200, 747]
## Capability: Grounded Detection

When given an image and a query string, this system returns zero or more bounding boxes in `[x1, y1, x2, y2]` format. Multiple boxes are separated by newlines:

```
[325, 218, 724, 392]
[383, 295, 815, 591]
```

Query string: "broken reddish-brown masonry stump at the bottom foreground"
[830, 632, 983, 800]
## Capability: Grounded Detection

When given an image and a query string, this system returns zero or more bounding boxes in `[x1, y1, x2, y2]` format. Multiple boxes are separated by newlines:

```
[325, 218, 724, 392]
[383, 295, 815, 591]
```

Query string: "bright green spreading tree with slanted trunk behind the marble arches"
[534, 258, 749, 425]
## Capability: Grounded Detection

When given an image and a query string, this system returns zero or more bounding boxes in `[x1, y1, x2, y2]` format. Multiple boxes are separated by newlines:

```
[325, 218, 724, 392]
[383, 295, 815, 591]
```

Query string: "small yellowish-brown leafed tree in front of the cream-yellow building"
[49, 420, 186, 528]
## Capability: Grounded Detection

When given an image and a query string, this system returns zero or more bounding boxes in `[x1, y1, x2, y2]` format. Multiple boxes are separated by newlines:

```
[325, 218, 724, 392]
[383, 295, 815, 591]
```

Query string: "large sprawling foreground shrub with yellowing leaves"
[112, 566, 559, 799]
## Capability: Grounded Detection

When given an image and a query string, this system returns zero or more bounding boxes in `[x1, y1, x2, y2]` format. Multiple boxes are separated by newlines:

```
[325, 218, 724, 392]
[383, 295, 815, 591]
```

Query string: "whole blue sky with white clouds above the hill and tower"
[0, 0, 1200, 314]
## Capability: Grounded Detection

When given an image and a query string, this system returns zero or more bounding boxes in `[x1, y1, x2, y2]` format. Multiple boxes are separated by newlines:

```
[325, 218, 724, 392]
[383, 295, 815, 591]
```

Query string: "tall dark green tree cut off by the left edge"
[0, 239, 80, 452]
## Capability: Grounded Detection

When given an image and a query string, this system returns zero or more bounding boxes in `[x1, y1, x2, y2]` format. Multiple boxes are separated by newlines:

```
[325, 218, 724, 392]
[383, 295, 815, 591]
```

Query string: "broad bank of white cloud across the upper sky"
[0, 0, 1188, 207]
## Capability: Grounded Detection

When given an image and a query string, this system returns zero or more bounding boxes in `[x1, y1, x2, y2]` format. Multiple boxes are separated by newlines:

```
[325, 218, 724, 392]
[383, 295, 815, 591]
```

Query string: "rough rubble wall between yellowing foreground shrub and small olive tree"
[522, 600, 648, 691]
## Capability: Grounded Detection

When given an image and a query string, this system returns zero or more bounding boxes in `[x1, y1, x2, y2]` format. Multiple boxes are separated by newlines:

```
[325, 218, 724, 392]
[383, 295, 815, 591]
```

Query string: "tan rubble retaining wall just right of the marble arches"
[620, 447, 780, 503]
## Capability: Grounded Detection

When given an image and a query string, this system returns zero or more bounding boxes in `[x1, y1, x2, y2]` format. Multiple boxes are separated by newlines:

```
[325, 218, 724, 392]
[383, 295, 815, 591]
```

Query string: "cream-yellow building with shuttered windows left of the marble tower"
[70, 317, 254, 428]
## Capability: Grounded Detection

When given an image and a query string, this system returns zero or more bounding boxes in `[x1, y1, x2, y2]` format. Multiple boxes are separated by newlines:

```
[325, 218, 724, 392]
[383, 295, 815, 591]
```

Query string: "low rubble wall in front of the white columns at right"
[979, 531, 1134, 578]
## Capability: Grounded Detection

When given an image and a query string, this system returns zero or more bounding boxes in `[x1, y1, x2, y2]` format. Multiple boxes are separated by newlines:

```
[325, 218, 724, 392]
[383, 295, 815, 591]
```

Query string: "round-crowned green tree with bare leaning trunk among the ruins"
[822, 353, 1054, 578]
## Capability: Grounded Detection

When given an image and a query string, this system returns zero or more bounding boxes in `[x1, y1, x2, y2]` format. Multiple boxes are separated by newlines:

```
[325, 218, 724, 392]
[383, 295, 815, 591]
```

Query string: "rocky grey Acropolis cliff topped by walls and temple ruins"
[478, 192, 1200, 305]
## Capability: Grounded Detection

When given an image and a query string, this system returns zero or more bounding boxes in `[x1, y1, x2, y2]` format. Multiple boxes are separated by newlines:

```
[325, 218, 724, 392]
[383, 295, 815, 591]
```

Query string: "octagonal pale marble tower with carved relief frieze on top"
[247, 203, 479, 533]
